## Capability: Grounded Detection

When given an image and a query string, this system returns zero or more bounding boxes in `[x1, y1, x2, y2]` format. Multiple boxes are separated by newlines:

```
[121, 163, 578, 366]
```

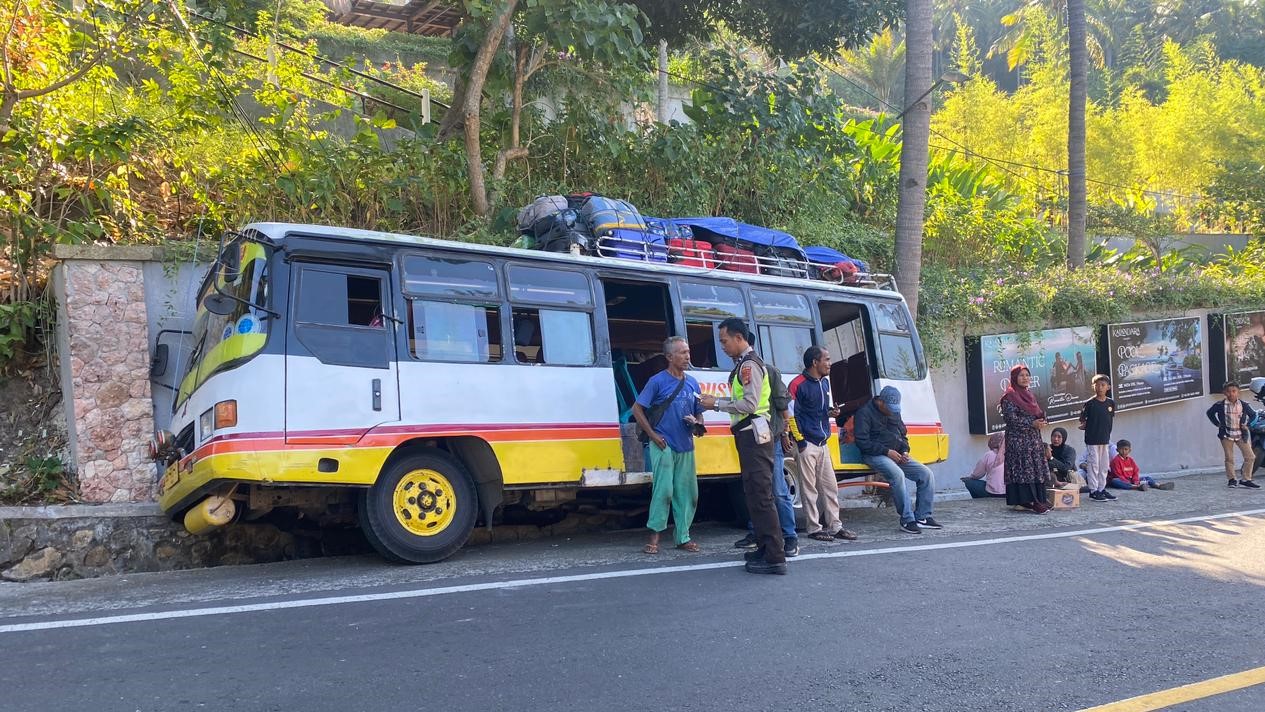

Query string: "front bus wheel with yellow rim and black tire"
[358, 450, 478, 564]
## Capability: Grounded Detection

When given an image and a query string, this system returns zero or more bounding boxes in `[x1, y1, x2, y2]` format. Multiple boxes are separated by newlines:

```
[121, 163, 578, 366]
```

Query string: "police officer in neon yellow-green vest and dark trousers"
[701, 316, 787, 574]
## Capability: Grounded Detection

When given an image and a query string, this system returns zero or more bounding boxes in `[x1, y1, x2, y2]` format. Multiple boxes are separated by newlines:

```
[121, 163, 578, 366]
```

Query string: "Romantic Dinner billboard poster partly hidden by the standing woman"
[968, 326, 1098, 434]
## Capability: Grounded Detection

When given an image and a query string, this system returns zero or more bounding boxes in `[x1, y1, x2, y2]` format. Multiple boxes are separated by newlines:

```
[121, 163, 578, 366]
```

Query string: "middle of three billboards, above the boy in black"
[1107, 316, 1204, 411]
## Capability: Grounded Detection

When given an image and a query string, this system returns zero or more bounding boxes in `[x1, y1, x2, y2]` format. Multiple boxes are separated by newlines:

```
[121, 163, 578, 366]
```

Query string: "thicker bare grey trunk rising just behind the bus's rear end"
[896, 0, 932, 316]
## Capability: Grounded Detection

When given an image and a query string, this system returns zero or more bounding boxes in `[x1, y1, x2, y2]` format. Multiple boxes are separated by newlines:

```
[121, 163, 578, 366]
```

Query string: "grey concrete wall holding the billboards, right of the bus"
[931, 310, 1222, 489]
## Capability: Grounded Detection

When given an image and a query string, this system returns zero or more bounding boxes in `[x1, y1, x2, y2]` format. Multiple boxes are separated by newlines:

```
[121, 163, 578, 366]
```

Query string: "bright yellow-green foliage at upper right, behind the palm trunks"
[931, 14, 1265, 230]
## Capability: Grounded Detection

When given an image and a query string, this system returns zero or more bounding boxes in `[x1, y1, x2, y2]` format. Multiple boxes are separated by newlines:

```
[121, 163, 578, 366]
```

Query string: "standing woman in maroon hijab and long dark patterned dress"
[1001, 364, 1051, 515]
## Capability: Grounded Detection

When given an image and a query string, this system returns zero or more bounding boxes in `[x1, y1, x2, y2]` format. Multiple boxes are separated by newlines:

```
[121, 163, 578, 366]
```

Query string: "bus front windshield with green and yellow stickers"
[175, 238, 269, 407]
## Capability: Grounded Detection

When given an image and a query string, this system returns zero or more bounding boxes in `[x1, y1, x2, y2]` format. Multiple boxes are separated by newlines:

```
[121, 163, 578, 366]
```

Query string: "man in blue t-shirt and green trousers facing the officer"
[633, 336, 703, 554]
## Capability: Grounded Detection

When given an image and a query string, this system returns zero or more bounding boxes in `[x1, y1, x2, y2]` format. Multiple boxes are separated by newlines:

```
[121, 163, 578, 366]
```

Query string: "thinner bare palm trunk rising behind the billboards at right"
[1068, 0, 1089, 269]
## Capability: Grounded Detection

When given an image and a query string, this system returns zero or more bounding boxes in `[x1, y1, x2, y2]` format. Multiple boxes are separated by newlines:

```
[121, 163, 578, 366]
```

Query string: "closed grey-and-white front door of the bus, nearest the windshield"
[286, 263, 400, 445]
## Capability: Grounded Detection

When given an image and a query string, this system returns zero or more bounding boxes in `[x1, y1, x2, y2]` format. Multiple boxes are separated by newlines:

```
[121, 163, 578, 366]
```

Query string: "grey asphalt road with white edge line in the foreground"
[0, 498, 1265, 712]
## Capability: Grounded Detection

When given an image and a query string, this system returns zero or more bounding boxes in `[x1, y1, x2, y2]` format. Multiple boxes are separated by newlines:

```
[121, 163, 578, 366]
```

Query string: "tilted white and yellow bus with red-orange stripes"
[153, 224, 949, 563]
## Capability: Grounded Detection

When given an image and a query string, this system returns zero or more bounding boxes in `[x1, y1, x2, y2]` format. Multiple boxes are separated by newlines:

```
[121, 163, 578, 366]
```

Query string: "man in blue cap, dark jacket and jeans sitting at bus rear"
[854, 386, 942, 534]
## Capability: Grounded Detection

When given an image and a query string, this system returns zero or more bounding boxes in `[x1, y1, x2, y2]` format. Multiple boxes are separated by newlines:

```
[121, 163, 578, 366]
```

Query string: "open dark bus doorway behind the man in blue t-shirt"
[602, 278, 676, 472]
